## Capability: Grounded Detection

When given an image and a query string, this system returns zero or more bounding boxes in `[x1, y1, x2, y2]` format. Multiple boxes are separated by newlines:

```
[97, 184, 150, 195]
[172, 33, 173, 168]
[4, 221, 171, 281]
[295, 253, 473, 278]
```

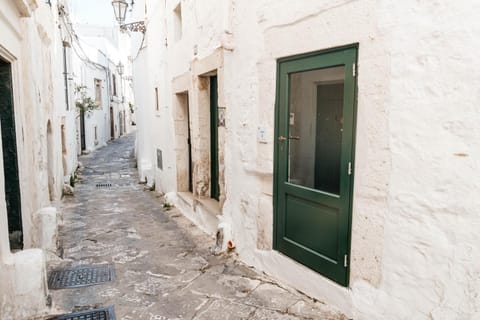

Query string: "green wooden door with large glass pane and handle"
[274, 47, 357, 286]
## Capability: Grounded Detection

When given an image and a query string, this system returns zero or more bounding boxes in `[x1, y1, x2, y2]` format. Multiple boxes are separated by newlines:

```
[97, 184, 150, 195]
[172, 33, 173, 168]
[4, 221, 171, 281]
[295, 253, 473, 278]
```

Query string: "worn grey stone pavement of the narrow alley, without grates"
[49, 134, 346, 320]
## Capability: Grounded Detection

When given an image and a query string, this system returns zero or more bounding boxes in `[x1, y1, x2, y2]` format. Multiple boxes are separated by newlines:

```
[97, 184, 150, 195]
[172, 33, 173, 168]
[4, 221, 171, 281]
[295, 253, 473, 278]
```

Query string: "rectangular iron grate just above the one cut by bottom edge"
[48, 264, 115, 288]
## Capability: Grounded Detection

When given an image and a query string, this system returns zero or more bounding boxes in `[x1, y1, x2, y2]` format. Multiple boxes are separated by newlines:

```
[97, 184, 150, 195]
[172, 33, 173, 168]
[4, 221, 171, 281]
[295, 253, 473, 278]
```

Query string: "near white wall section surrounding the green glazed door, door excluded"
[224, 1, 480, 319]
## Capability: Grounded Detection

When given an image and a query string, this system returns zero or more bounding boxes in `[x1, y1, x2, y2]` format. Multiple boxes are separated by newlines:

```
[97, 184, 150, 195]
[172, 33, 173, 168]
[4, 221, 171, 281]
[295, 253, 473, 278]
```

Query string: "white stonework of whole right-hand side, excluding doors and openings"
[132, 0, 480, 320]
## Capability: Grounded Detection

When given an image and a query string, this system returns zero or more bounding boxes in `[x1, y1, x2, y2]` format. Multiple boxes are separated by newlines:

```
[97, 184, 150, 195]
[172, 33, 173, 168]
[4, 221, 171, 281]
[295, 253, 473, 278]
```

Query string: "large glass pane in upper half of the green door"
[288, 66, 345, 195]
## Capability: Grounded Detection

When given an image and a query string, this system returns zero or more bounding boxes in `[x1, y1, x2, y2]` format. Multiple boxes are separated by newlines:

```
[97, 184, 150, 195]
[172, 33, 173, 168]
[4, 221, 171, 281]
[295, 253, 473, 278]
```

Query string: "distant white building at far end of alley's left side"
[73, 25, 129, 152]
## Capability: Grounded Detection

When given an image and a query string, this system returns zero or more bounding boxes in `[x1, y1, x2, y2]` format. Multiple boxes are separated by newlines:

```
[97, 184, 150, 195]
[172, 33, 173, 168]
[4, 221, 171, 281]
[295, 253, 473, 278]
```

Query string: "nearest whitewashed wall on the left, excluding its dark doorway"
[0, 0, 74, 320]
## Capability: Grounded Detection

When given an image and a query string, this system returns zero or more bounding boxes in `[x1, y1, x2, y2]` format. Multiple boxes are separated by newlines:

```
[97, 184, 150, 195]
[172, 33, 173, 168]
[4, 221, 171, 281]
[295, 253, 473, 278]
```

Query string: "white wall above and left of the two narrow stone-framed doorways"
[132, 0, 224, 192]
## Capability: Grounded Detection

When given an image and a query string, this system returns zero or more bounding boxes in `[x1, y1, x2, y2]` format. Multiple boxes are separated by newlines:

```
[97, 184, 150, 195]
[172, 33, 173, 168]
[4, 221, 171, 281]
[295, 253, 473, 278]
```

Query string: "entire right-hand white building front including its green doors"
[132, 0, 480, 319]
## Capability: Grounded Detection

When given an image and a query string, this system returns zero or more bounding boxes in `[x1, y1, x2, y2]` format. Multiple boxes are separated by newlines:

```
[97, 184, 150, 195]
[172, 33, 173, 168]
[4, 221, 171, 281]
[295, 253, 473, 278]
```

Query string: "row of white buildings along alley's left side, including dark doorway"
[0, 0, 131, 320]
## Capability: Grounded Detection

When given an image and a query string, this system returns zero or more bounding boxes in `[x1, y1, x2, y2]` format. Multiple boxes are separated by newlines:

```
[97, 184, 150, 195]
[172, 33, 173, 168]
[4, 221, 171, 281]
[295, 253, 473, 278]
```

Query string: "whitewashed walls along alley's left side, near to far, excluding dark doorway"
[0, 0, 126, 320]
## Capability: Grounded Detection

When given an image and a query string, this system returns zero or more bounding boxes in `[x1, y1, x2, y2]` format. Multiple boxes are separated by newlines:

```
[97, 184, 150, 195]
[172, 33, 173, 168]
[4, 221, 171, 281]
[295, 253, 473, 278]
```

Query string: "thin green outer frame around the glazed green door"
[272, 43, 359, 287]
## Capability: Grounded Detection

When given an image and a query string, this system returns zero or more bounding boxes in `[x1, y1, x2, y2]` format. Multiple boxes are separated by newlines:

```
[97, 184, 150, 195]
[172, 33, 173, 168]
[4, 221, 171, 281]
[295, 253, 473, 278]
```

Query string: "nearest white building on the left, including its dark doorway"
[0, 0, 77, 320]
